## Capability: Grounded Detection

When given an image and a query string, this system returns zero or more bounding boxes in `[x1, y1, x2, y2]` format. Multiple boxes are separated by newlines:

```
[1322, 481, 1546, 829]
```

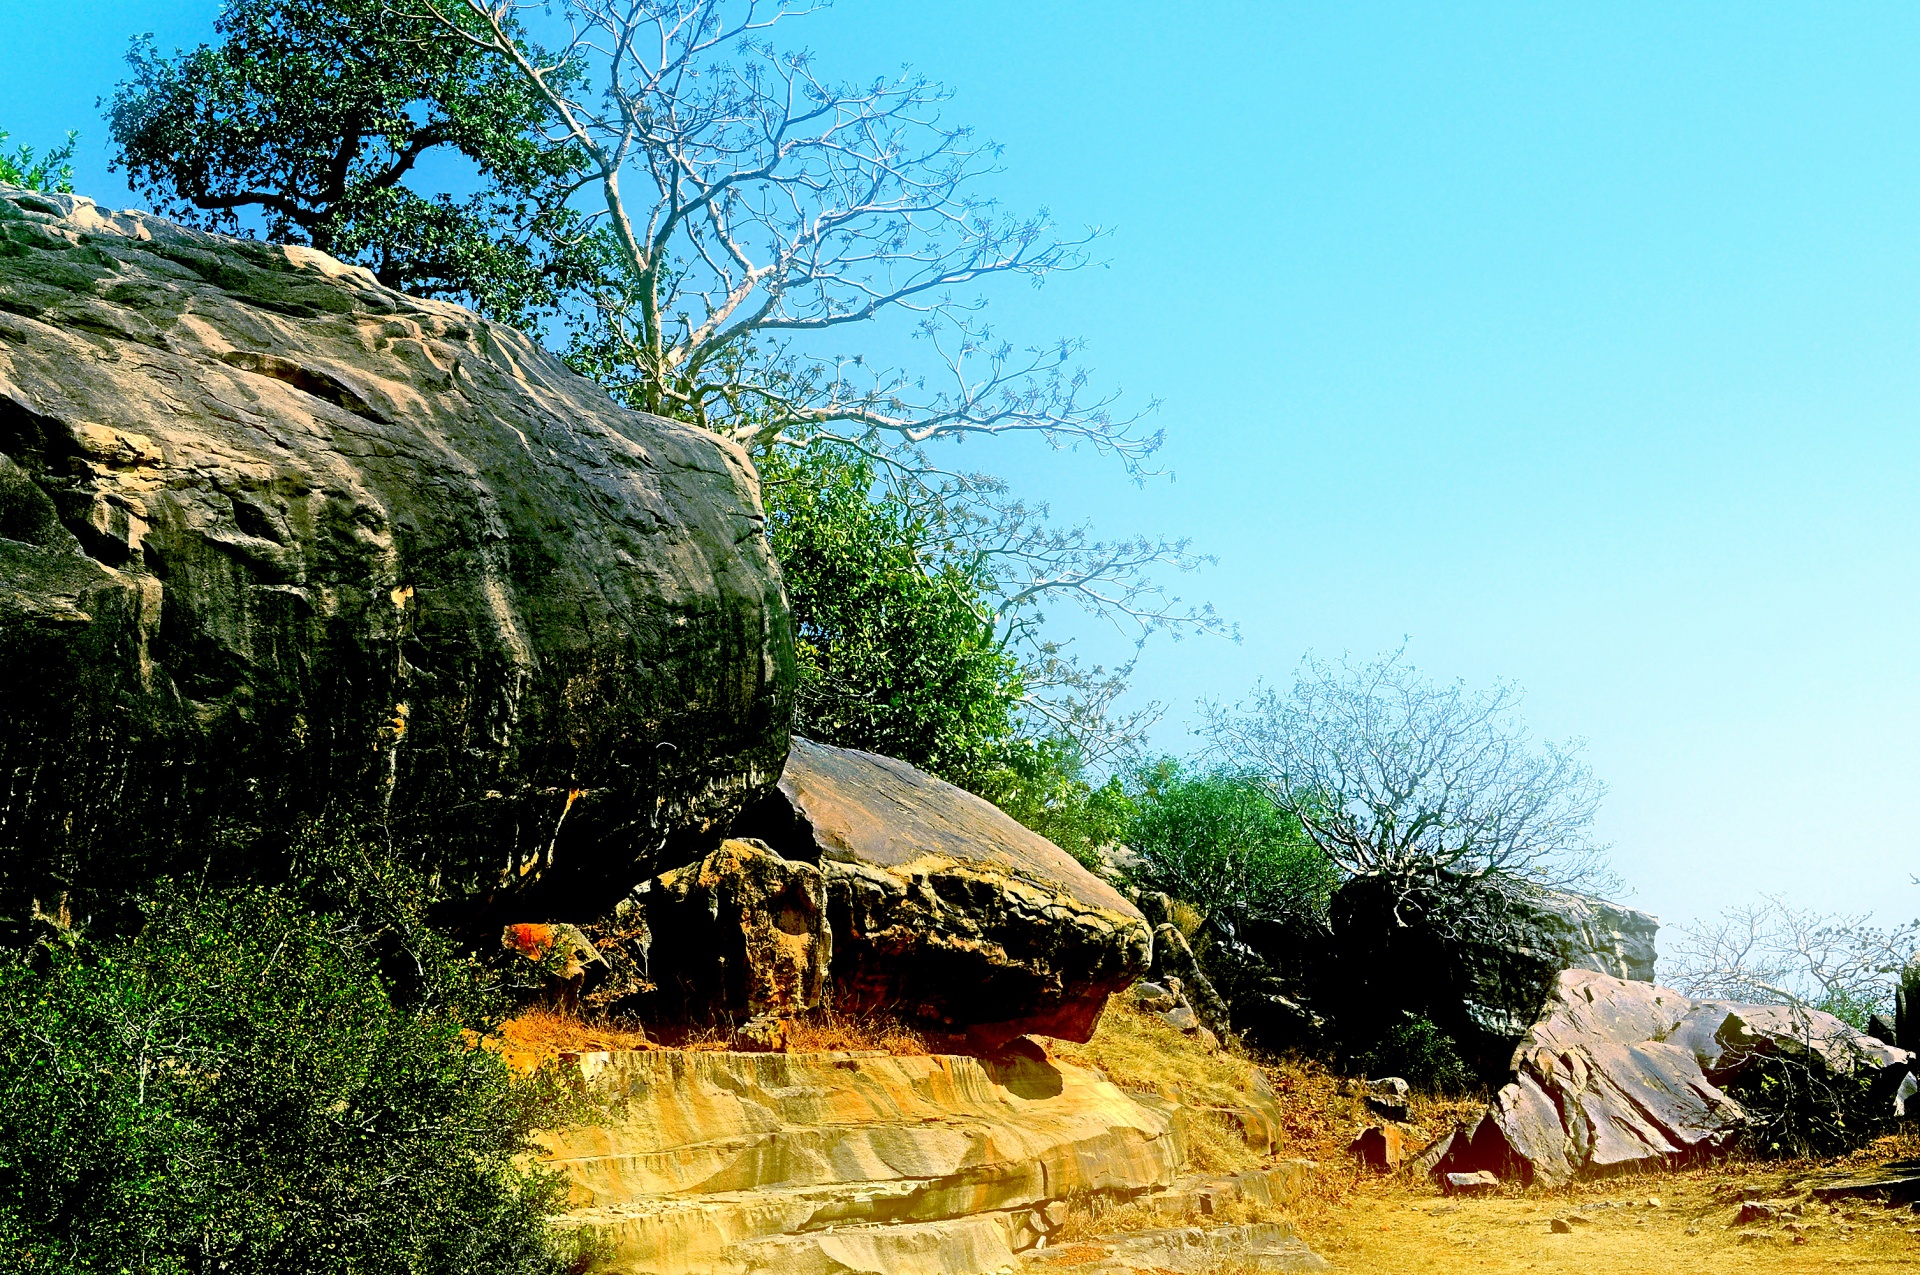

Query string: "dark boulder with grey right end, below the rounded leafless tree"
[1315, 872, 1659, 1075]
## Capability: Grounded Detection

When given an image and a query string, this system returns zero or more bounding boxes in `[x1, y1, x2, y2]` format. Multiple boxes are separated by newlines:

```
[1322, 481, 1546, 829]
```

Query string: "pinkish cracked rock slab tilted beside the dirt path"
[1436, 970, 1912, 1183]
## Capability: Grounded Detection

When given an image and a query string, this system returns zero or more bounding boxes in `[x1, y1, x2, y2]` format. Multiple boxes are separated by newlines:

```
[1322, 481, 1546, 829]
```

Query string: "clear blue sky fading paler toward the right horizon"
[0, 0, 1920, 937]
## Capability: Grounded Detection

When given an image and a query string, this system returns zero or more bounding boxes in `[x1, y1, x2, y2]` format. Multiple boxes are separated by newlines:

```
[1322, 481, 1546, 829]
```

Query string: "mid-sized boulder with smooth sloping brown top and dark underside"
[735, 739, 1152, 1046]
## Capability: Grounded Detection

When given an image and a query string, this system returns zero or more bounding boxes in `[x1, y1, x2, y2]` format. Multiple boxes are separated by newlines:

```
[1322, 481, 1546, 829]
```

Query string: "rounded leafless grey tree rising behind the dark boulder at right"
[1204, 651, 1613, 889]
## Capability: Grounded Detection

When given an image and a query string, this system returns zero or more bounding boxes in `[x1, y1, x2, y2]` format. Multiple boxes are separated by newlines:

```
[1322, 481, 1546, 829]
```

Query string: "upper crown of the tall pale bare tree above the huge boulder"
[410, 0, 1160, 472]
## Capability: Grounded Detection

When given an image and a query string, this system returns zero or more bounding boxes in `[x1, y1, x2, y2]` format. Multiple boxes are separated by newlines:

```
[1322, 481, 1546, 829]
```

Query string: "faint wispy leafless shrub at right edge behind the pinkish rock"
[1661, 895, 1920, 1025]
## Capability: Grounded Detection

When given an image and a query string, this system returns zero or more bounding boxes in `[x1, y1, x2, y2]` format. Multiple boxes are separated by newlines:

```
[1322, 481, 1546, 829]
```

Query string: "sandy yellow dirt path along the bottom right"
[1294, 1167, 1920, 1275]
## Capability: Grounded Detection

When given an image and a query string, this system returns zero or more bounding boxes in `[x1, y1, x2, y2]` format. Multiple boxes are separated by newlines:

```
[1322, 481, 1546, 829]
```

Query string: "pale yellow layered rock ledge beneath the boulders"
[541, 1050, 1182, 1275]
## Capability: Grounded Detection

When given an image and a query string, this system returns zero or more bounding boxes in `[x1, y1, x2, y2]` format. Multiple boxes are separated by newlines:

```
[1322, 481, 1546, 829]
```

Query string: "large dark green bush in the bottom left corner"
[0, 872, 566, 1275]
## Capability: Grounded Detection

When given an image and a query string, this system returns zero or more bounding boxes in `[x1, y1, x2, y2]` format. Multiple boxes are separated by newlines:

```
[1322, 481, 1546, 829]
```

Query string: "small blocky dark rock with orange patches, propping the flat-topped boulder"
[645, 839, 833, 1048]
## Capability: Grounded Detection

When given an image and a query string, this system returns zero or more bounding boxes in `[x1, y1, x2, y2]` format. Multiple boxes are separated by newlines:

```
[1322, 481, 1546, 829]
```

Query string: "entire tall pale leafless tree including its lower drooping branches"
[410, 0, 1231, 762]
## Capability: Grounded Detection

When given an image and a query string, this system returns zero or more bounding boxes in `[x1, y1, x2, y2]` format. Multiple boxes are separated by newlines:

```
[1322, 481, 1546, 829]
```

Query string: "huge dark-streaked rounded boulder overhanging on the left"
[0, 188, 793, 920]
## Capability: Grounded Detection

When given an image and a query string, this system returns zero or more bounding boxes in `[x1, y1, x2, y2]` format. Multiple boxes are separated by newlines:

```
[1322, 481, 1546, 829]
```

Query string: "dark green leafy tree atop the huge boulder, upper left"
[108, 0, 589, 325]
